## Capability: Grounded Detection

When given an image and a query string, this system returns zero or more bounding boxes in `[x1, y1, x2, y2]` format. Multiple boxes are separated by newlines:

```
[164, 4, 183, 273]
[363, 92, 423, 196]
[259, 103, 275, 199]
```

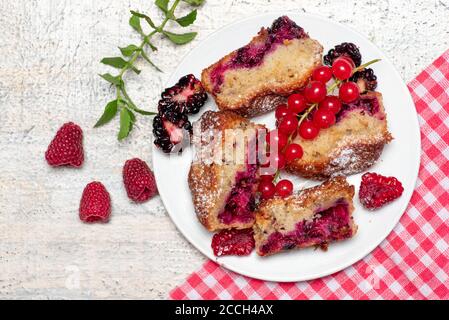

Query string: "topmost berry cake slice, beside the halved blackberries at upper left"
[201, 16, 323, 117]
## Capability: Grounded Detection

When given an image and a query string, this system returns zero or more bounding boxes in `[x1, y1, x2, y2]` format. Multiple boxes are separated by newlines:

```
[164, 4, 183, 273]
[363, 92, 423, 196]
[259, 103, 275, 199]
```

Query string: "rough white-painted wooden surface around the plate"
[0, 0, 449, 299]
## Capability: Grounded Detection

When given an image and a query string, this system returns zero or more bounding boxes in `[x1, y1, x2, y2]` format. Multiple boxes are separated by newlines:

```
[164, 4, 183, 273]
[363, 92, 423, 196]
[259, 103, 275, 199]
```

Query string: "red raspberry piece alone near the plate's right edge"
[359, 172, 404, 210]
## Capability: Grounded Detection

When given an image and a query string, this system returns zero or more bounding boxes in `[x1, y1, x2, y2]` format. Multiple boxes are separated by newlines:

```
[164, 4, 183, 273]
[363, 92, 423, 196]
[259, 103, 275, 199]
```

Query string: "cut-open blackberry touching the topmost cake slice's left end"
[158, 74, 207, 114]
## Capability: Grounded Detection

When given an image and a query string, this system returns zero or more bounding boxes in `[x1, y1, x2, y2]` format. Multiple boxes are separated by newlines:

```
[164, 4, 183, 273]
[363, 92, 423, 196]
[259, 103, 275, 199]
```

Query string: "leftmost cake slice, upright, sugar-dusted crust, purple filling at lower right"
[188, 111, 266, 231]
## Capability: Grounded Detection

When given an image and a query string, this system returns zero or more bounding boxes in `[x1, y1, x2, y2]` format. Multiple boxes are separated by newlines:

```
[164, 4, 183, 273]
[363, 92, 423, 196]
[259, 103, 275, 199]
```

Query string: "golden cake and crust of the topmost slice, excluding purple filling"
[201, 17, 323, 117]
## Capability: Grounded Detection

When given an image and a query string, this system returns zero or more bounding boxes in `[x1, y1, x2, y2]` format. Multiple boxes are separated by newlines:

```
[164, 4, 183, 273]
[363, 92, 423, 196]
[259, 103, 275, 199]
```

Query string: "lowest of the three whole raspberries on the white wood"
[79, 181, 111, 223]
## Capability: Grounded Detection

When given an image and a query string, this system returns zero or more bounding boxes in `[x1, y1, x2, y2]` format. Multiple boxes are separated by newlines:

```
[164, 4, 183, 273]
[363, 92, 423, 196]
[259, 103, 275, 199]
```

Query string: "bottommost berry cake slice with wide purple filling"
[254, 177, 357, 256]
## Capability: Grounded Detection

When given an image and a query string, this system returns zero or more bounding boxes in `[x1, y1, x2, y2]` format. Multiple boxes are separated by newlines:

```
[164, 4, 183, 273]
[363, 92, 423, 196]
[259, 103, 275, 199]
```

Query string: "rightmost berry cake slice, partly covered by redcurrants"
[286, 91, 393, 180]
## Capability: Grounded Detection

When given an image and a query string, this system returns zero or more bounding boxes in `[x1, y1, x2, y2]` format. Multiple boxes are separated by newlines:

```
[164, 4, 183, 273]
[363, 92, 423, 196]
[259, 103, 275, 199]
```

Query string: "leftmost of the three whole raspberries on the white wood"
[45, 122, 84, 167]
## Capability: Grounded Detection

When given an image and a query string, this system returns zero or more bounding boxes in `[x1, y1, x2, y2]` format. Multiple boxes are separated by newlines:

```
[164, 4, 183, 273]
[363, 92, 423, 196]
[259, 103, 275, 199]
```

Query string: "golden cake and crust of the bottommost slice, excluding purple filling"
[253, 176, 357, 256]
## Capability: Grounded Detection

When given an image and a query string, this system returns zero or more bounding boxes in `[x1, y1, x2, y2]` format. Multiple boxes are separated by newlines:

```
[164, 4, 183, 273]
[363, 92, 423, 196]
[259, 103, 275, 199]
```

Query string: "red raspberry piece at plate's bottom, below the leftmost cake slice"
[211, 229, 255, 257]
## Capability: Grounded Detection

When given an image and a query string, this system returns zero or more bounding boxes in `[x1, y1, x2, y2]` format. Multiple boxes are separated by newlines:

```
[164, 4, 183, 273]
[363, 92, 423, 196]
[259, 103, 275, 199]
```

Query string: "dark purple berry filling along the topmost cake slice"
[211, 16, 307, 92]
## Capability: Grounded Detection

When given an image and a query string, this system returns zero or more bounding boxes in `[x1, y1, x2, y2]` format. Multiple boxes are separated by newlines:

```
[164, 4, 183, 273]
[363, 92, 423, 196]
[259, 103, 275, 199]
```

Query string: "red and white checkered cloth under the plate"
[170, 50, 449, 299]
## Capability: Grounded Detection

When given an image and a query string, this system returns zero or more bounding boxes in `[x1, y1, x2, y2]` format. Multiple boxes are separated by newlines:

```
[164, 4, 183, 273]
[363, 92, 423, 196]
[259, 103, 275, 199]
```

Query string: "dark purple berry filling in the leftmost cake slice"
[218, 165, 257, 224]
